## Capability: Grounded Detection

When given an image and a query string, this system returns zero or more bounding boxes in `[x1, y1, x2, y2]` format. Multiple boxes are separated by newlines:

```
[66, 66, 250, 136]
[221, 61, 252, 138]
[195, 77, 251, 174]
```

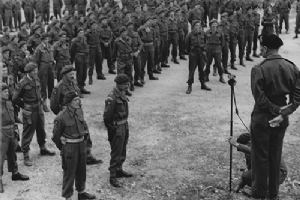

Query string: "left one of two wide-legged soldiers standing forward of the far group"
[185, 20, 211, 94]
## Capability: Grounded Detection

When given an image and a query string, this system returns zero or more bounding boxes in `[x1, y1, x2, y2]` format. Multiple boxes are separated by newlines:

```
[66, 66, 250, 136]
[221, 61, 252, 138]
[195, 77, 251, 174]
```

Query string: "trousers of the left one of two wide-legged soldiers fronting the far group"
[187, 52, 205, 85]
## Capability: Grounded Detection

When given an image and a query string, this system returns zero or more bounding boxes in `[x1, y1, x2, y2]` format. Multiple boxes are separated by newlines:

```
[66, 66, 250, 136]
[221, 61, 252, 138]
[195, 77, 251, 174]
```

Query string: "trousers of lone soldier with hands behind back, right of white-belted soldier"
[108, 123, 129, 178]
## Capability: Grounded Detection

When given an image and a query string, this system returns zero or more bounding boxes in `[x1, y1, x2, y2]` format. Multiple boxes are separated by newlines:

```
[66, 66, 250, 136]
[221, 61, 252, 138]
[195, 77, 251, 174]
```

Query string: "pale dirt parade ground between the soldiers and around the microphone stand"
[0, 2, 300, 200]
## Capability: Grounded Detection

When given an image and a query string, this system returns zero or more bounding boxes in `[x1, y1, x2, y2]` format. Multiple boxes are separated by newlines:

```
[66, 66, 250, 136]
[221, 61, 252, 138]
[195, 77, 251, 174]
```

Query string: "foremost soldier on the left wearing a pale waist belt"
[52, 91, 96, 200]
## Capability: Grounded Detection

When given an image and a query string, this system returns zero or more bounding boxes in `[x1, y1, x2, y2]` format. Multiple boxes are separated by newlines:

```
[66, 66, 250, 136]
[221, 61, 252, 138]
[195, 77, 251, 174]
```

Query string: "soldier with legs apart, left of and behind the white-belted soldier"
[12, 62, 55, 166]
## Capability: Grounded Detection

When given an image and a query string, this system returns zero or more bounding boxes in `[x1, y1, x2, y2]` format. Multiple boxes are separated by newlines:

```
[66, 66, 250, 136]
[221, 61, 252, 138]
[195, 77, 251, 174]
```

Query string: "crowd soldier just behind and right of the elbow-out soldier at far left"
[33, 33, 55, 112]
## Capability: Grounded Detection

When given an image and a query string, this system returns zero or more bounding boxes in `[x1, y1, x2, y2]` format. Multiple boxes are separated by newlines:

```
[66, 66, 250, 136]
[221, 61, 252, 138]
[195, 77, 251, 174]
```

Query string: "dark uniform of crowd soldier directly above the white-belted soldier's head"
[71, 33, 89, 90]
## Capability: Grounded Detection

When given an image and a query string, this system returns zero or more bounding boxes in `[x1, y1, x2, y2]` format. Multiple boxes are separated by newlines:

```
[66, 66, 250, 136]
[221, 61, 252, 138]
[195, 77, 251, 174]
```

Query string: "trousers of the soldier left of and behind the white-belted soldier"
[21, 105, 46, 153]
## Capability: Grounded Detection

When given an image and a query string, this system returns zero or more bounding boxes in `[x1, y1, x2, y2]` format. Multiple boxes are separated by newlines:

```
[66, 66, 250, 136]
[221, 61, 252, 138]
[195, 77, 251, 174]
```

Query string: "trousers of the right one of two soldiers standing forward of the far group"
[205, 47, 224, 76]
